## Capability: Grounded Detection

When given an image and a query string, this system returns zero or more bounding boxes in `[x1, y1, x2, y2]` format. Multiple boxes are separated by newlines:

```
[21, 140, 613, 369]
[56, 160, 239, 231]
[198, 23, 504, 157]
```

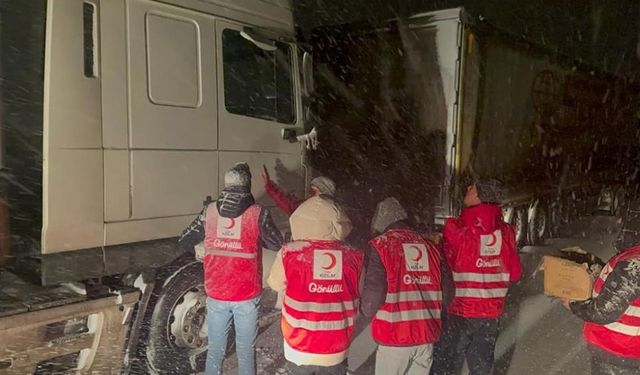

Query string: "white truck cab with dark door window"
[41, 0, 304, 254]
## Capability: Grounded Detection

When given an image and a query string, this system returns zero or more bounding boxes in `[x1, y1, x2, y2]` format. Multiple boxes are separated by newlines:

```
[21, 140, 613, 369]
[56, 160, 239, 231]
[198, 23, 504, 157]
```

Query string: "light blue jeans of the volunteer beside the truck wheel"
[205, 296, 260, 375]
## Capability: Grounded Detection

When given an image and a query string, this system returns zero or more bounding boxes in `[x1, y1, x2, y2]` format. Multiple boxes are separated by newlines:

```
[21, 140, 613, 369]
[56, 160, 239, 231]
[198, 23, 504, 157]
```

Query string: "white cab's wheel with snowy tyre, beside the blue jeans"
[146, 262, 207, 374]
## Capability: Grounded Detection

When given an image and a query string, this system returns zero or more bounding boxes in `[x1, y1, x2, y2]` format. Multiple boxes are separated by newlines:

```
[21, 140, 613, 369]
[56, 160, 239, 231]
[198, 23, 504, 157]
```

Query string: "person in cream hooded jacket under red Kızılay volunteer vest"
[268, 196, 364, 375]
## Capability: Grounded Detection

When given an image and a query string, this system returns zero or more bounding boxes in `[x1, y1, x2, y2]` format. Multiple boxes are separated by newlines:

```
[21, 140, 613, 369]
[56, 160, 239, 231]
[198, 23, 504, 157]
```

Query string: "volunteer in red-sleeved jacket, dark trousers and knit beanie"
[431, 180, 522, 375]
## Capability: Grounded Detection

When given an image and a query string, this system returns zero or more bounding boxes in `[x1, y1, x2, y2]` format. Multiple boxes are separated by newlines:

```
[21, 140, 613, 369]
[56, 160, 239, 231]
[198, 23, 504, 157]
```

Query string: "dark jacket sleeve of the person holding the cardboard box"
[570, 259, 640, 325]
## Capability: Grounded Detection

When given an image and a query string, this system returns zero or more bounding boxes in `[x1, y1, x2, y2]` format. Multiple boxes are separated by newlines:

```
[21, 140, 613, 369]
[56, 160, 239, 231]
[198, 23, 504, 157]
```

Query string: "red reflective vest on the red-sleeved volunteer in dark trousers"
[447, 219, 517, 318]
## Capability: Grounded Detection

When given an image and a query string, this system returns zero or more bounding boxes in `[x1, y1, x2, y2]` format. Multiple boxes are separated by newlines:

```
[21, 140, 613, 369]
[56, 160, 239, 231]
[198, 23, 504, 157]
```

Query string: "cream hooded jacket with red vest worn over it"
[267, 196, 364, 366]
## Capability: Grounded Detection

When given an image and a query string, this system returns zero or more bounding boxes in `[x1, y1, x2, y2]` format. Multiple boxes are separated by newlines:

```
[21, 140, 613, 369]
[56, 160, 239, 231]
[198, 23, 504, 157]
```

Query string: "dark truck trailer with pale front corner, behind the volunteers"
[309, 8, 639, 246]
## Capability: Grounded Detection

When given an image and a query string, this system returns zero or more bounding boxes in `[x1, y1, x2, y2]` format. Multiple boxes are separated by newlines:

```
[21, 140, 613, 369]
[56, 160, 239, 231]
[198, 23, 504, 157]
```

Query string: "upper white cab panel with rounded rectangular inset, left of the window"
[128, 0, 217, 150]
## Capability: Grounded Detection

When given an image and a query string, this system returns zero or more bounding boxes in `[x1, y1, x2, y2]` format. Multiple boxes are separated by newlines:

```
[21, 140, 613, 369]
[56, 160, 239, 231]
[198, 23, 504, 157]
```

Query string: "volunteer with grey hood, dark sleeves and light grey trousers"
[359, 198, 442, 375]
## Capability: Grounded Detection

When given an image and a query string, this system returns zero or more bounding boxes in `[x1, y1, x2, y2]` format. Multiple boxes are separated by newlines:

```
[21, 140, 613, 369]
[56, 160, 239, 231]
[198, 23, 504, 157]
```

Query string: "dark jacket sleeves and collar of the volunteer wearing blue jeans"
[178, 187, 283, 251]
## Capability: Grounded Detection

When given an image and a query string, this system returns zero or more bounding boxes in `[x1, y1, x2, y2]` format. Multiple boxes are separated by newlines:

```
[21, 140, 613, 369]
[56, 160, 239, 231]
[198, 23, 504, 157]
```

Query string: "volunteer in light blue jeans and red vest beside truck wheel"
[179, 163, 282, 375]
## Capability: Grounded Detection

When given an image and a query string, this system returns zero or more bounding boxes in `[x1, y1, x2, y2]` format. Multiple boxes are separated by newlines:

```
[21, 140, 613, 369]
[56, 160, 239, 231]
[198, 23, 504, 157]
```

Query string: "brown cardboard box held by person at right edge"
[542, 255, 593, 301]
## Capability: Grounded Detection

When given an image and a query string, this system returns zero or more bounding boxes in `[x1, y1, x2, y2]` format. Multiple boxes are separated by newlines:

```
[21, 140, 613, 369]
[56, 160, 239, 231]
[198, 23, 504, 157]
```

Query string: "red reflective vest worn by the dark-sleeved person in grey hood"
[369, 229, 442, 346]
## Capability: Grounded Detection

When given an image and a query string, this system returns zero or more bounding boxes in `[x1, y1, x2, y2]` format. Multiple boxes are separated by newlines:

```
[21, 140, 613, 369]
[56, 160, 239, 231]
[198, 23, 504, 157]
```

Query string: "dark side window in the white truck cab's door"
[222, 29, 295, 124]
